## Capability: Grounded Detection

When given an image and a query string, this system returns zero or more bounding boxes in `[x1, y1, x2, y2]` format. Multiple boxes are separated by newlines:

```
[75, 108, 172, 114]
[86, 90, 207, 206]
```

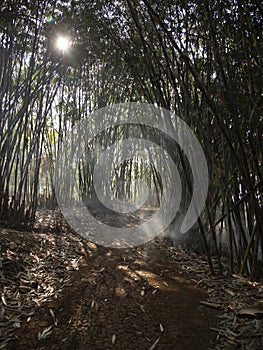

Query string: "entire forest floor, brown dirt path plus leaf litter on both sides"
[0, 212, 263, 350]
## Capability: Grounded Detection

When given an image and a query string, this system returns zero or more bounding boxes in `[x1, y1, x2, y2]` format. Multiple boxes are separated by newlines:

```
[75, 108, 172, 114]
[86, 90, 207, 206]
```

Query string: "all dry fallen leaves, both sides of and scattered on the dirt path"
[0, 209, 263, 350]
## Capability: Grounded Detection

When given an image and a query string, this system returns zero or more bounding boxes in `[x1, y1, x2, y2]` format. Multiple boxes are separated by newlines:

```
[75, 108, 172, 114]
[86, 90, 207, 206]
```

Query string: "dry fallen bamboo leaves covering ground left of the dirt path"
[0, 211, 91, 349]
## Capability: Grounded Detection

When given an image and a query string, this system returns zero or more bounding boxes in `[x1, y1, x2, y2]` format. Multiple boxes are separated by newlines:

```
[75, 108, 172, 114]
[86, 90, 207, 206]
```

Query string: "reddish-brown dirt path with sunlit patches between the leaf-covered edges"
[8, 242, 219, 350]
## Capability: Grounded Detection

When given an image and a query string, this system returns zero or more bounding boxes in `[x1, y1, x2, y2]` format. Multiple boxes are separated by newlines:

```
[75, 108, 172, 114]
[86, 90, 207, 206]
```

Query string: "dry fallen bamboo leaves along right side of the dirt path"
[164, 243, 263, 350]
